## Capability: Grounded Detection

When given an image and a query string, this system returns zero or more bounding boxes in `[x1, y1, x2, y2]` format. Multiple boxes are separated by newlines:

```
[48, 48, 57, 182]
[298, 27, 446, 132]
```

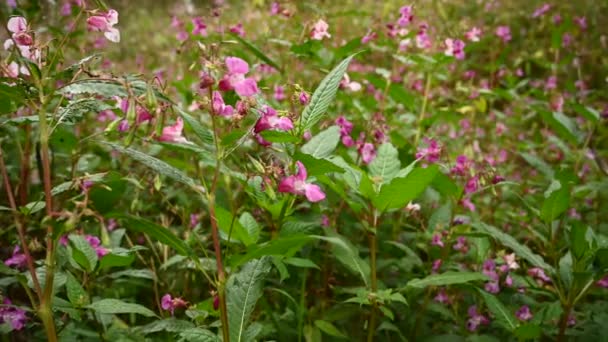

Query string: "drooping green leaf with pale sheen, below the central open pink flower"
[312, 230, 370, 286]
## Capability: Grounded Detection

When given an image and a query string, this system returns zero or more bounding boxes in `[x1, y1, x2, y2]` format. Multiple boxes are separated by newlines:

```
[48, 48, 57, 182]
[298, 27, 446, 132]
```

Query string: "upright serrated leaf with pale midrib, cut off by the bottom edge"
[226, 257, 270, 342]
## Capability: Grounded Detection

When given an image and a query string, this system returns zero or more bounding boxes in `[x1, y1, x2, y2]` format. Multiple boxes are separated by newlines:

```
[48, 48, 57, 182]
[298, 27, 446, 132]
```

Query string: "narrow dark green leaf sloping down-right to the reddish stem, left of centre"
[107, 213, 192, 256]
